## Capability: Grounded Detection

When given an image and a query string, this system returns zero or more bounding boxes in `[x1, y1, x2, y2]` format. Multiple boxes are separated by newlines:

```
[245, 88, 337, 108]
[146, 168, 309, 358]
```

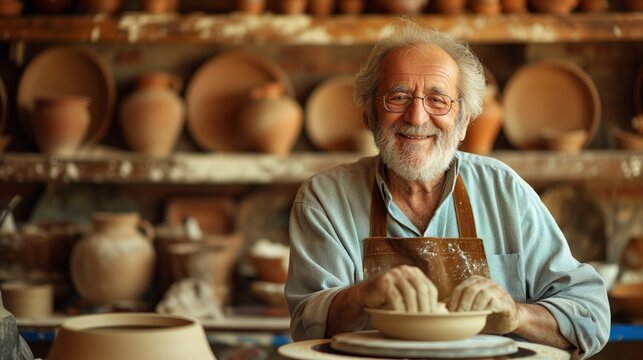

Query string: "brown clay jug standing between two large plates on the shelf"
[120, 72, 185, 156]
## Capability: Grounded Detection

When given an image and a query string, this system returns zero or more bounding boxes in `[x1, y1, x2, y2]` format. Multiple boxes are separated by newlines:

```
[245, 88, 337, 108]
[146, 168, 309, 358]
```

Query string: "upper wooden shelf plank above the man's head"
[0, 13, 643, 45]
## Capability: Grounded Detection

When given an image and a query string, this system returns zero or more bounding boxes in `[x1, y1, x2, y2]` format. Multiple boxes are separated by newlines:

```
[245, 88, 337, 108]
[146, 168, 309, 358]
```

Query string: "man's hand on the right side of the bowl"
[447, 275, 520, 335]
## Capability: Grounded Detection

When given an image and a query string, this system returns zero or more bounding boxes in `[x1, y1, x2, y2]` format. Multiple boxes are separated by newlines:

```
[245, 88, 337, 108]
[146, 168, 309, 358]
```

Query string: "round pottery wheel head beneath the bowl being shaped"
[330, 330, 518, 359]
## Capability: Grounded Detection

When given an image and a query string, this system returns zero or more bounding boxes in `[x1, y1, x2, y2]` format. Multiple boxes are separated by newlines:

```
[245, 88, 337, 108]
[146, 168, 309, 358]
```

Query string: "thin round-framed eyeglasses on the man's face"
[376, 90, 462, 115]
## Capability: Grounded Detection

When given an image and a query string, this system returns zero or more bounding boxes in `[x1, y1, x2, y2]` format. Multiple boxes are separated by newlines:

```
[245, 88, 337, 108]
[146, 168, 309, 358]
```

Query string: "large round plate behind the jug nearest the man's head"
[186, 50, 293, 151]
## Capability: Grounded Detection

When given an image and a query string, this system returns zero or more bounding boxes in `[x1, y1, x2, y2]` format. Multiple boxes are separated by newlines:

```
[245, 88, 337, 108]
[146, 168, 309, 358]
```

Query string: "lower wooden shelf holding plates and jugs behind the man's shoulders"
[0, 150, 643, 185]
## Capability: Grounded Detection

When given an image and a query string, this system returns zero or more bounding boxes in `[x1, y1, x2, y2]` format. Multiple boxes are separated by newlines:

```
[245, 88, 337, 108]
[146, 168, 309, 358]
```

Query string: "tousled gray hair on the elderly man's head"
[355, 18, 485, 127]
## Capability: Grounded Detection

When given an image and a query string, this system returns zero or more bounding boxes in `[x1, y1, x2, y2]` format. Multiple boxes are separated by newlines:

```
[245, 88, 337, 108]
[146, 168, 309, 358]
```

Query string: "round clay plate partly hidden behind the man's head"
[306, 76, 365, 151]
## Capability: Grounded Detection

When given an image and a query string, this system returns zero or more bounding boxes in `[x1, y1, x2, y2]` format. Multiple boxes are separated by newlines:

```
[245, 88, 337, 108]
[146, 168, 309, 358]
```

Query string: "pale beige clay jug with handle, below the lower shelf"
[71, 212, 156, 305]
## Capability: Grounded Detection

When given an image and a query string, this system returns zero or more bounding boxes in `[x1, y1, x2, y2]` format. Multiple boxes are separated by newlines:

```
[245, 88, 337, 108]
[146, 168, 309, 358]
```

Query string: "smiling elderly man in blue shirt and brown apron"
[286, 19, 610, 357]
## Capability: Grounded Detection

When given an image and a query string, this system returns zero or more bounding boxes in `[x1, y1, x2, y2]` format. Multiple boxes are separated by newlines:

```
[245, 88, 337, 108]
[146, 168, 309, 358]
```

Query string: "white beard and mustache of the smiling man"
[373, 119, 466, 182]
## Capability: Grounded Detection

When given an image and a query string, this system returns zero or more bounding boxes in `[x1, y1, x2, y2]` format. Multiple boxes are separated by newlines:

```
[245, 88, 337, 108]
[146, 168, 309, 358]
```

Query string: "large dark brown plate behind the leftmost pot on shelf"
[17, 46, 116, 144]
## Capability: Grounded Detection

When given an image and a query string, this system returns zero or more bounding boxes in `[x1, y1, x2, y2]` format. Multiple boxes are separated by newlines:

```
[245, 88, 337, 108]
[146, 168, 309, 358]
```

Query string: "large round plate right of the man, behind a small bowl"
[503, 60, 601, 149]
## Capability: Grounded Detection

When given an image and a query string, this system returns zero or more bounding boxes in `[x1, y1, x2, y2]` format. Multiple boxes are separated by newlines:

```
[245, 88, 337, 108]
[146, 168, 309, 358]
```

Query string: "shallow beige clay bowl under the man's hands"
[366, 309, 491, 341]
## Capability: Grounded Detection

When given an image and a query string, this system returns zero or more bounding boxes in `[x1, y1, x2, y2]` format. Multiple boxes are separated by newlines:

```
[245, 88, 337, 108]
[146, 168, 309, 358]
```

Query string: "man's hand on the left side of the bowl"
[356, 265, 438, 312]
